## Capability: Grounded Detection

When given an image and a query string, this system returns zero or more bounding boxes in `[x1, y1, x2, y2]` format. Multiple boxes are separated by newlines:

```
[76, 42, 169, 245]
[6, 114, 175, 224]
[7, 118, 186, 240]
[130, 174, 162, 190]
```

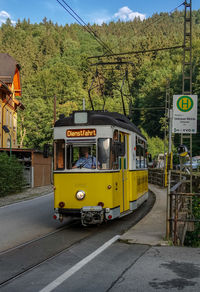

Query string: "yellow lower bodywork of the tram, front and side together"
[54, 170, 148, 213]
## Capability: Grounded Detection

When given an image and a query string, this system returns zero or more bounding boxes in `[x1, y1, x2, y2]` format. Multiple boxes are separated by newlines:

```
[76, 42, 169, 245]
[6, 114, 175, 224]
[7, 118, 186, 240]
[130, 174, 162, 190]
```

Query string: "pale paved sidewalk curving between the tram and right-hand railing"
[120, 184, 168, 246]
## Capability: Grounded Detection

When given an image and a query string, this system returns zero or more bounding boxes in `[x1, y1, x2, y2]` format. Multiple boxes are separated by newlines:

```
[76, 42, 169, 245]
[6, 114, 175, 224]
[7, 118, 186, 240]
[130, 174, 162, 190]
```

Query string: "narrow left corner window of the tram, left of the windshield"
[54, 140, 65, 170]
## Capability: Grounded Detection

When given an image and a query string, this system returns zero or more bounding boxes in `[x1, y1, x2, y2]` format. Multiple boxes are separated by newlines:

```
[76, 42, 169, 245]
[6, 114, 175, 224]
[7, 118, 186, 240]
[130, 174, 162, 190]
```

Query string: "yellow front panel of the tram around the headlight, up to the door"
[54, 172, 122, 209]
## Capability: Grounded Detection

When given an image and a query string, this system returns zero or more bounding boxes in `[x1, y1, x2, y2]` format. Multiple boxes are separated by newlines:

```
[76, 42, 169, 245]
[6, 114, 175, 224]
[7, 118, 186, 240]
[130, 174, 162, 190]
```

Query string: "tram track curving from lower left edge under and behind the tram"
[0, 190, 155, 288]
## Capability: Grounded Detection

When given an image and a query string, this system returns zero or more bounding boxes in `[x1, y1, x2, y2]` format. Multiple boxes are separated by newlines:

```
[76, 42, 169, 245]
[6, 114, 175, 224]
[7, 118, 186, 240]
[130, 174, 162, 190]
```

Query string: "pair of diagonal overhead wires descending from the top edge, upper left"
[56, 0, 113, 54]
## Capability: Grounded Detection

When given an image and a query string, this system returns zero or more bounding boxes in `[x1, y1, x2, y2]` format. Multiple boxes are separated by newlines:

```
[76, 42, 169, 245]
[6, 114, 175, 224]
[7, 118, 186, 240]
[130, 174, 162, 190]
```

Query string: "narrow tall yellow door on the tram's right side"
[120, 132, 129, 212]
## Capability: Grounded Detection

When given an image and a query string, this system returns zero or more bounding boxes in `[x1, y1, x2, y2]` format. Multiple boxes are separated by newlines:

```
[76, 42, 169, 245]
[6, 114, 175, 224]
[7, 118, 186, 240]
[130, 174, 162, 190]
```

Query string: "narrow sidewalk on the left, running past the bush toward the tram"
[0, 185, 53, 207]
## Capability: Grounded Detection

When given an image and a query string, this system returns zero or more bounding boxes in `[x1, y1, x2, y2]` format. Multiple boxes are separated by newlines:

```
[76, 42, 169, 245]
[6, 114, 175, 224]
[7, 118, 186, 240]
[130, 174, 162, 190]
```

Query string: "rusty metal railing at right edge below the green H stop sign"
[169, 171, 200, 245]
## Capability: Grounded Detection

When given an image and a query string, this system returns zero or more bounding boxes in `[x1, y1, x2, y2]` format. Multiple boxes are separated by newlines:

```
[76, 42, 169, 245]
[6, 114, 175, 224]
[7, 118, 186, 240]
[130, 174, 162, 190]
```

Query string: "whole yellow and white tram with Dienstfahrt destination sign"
[54, 111, 148, 225]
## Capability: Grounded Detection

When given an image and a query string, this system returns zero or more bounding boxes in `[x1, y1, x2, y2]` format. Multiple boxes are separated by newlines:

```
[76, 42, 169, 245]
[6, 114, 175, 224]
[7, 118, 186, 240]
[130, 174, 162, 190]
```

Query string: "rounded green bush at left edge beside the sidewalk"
[0, 153, 24, 197]
